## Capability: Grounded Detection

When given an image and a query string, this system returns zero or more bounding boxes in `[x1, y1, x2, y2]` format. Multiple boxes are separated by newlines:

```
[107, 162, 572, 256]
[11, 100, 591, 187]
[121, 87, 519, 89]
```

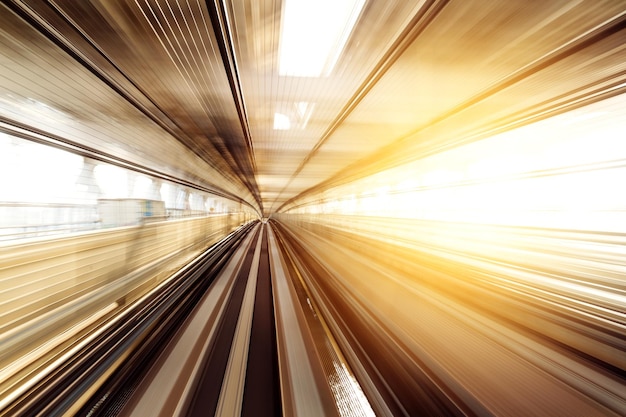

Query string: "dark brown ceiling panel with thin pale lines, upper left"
[32, 0, 258, 208]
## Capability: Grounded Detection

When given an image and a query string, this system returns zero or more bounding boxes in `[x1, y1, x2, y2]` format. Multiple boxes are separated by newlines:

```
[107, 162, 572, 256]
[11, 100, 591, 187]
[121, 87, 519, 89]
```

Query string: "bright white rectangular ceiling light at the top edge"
[279, 0, 365, 77]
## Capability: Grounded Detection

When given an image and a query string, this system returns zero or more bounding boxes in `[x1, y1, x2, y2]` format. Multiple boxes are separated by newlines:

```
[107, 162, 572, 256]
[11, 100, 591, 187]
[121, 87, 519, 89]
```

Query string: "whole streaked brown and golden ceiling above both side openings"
[4, 0, 626, 214]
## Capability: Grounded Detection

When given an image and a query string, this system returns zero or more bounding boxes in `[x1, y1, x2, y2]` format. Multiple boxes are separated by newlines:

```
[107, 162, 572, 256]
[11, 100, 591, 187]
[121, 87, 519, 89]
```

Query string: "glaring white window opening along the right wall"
[286, 95, 626, 233]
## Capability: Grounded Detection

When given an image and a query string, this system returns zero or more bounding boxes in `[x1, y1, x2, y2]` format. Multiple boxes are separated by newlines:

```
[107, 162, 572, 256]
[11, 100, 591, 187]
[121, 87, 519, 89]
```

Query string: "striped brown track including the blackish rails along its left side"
[0, 222, 376, 416]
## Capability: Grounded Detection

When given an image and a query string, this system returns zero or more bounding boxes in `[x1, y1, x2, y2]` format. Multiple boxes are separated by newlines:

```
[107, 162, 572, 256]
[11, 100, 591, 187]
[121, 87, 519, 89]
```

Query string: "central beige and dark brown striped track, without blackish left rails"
[108, 224, 371, 416]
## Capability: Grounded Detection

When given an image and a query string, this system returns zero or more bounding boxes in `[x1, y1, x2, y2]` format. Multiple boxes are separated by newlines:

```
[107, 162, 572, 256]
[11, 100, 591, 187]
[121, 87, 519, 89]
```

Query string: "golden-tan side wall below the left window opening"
[0, 213, 252, 399]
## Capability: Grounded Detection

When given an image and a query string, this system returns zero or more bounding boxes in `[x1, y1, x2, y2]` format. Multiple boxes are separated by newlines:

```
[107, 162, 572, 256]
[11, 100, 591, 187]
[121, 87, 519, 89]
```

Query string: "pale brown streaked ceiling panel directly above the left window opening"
[0, 1, 254, 206]
